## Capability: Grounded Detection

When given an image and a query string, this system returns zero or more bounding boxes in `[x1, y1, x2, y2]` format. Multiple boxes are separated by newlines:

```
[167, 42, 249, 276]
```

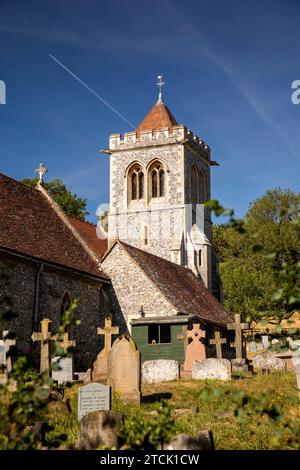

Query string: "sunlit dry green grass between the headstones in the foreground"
[49, 372, 300, 450]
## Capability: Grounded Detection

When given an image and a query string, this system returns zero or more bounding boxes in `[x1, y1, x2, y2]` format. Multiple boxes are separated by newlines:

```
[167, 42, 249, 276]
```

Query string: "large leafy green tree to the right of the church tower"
[214, 188, 300, 320]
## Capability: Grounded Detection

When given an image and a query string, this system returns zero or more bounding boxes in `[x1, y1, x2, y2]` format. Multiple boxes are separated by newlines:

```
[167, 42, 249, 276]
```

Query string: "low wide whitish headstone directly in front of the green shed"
[142, 359, 179, 384]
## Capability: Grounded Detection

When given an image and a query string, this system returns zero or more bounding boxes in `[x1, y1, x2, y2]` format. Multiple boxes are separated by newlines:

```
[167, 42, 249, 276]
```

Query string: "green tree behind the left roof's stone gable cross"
[21, 178, 89, 220]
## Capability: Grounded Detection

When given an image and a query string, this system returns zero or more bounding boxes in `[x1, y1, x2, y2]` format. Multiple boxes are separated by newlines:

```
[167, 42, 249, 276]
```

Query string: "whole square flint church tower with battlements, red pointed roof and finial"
[105, 76, 216, 290]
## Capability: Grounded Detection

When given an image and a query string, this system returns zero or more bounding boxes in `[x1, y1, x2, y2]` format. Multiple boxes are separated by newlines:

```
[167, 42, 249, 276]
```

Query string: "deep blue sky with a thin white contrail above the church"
[0, 0, 300, 220]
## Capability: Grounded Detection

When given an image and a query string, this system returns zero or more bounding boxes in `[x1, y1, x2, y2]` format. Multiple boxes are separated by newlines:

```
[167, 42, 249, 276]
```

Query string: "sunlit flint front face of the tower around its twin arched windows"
[109, 144, 183, 259]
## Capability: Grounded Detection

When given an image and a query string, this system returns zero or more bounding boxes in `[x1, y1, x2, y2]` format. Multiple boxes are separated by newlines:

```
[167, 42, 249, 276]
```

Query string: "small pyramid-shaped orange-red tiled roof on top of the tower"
[136, 102, 178, 133]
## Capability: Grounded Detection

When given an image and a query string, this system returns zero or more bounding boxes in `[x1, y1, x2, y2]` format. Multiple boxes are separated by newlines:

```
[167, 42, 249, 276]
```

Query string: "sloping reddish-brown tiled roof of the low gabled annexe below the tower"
[119, 242, 233, 325]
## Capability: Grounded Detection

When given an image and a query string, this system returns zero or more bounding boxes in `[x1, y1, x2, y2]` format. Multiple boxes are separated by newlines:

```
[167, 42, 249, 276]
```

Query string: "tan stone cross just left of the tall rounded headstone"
[93, 317, 119, 381]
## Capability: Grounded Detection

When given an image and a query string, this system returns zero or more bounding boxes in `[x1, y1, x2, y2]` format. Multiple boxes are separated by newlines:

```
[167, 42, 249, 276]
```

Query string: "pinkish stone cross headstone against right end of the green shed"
[177, 323, 206, 371]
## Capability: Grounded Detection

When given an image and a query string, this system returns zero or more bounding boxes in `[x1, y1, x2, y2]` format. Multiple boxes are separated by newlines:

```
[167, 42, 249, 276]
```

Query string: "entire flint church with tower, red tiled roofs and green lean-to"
[0, 82, 232, 370]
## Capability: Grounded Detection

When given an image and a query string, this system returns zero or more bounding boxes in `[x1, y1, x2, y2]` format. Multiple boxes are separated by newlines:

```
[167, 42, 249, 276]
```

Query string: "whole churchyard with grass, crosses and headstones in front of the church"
[0, 315, 300, 450]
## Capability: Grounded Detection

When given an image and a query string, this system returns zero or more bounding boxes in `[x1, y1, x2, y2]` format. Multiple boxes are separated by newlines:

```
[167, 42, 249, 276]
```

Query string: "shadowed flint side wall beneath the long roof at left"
[0, 254, 107, 370]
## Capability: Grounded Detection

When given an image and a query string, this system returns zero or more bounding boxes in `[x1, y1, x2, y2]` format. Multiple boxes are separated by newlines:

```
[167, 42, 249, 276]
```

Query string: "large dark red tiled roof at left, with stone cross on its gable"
[0, 173, 107, 278]
